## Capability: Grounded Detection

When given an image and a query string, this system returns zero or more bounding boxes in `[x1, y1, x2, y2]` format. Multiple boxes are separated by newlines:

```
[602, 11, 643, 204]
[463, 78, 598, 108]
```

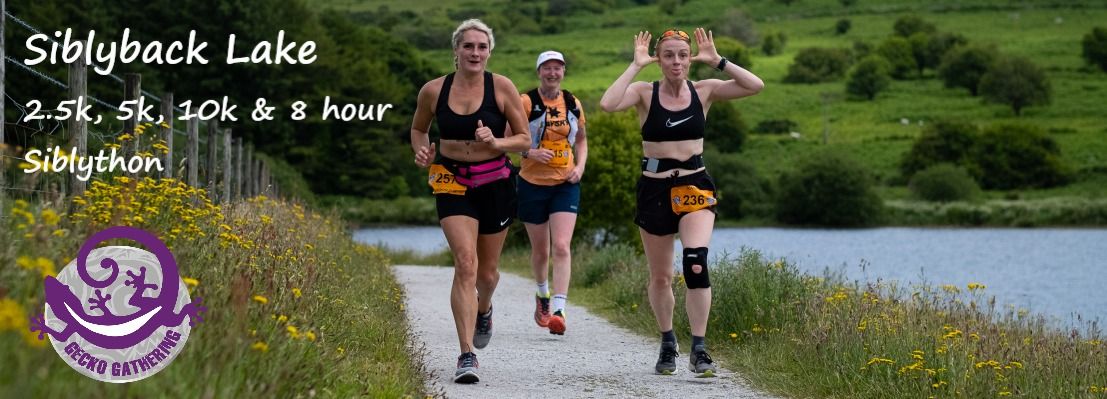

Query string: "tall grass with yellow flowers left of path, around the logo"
[0, 177, 425, 398]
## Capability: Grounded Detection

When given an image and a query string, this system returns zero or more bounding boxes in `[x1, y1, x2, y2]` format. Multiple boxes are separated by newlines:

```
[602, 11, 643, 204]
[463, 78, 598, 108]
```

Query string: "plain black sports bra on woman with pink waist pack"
[434, 72, 507, 140]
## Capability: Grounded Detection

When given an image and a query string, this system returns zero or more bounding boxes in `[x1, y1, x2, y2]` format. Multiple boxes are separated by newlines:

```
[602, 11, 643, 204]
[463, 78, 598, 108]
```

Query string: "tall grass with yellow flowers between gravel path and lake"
[505, 246, 1107, 398]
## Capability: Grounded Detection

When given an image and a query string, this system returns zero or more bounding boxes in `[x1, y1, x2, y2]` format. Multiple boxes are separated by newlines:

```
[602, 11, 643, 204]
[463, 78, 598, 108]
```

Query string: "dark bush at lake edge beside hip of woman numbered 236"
[708, 154, 773, 219]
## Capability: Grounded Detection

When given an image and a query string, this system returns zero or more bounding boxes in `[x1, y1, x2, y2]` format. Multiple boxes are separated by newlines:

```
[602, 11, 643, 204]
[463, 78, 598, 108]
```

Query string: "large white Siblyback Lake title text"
[23, 28, 317, 75]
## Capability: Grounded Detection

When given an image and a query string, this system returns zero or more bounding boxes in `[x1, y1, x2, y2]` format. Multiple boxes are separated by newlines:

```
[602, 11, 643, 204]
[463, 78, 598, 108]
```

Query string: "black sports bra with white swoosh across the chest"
[642, 81, 707, 142]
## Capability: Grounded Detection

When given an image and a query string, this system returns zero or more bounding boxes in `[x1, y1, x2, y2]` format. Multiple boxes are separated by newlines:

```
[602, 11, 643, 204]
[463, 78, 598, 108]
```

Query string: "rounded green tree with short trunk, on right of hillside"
[980, 57, 1052, 116]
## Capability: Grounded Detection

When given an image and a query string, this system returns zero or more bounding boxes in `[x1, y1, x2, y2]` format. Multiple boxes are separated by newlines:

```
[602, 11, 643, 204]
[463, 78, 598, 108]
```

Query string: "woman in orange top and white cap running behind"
[518, 51, 588, 335]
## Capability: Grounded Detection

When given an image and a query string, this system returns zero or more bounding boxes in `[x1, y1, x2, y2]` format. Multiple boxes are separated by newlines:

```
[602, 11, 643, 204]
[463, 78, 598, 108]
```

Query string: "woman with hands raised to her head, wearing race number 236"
[600, 28, 765, 377]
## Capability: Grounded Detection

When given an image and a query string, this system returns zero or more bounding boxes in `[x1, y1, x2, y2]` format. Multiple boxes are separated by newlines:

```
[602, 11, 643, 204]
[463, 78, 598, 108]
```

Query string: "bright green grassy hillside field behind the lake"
[315, 0, 1107, 207]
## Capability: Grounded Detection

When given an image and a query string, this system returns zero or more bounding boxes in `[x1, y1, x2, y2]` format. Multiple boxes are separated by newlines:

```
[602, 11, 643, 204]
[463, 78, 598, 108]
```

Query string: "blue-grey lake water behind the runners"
[354, 227, 1107, 325]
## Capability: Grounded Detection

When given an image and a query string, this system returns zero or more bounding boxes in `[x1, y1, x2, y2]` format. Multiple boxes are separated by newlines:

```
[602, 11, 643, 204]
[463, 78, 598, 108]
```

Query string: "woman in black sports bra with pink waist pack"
[411, 19, 530, 383]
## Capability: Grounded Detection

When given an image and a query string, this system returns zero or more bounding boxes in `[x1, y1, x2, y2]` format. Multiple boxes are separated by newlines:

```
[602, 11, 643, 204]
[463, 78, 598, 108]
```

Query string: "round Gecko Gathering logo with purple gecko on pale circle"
[31, 226, 207, 382]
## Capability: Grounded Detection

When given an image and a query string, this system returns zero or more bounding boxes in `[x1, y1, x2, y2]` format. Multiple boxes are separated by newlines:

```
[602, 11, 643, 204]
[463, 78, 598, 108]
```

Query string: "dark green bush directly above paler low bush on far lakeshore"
[900, 121, 980, 177]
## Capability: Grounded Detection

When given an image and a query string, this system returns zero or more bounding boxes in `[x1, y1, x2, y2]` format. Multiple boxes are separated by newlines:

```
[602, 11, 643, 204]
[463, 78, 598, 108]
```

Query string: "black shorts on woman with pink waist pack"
[434, 178, 516, 234]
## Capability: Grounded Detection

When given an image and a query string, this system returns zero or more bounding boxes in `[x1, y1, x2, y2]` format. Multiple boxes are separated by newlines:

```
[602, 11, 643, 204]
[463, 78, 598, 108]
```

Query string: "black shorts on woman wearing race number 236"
[634, 171, 717, 235]
